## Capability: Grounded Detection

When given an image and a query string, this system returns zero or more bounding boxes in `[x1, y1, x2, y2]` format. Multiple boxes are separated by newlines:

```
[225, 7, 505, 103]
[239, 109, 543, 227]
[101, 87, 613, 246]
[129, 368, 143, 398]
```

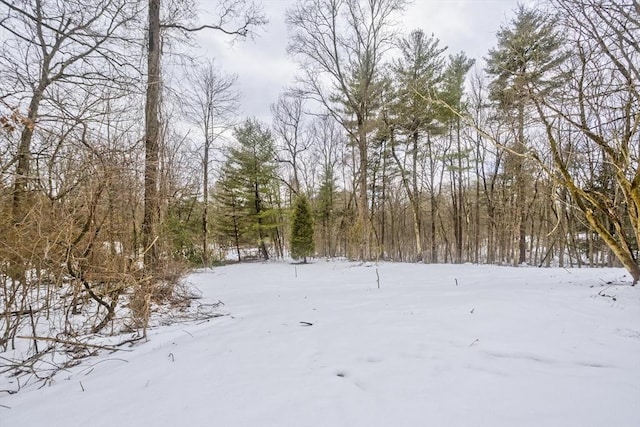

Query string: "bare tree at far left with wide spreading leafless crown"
[0, 0, 139, 223]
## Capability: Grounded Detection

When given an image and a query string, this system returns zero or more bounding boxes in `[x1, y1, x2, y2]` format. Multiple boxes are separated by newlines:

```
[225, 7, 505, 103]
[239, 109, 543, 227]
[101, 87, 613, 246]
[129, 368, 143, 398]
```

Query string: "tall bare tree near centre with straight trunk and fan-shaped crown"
[287, 0, 406, 259]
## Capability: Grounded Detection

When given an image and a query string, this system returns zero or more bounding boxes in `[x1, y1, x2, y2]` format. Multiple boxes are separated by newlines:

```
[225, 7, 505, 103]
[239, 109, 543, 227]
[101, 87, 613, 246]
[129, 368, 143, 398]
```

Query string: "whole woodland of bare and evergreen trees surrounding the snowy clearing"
[0, 0, 640, 362]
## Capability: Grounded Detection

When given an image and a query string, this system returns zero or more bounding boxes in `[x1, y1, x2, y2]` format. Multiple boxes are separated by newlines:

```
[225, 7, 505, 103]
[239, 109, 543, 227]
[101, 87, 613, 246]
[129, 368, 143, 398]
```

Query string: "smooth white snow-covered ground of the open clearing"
[0, 261, 640, 427]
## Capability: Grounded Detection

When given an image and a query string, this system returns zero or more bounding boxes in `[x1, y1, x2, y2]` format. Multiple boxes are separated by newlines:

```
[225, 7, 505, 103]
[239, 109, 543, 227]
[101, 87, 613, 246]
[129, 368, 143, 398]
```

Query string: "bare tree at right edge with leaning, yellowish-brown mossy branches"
[529, 0, 640, 283]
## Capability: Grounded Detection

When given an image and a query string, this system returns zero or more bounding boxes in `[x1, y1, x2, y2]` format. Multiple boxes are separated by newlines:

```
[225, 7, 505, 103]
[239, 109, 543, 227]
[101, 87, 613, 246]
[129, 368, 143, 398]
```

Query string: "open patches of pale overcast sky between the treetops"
[200, 0, 528, 123]
